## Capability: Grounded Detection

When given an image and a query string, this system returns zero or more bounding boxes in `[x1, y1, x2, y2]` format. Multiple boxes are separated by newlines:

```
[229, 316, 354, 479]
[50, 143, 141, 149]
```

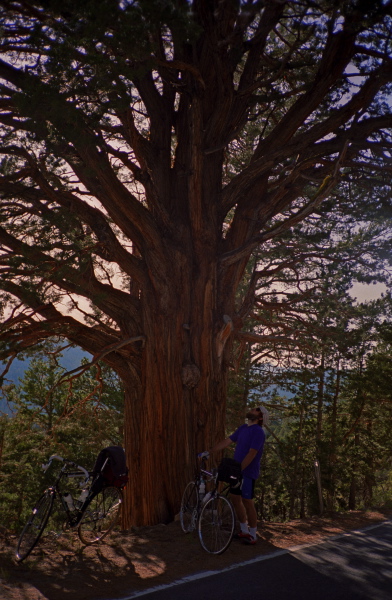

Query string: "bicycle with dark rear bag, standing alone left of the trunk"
[16, 454, 123, 562]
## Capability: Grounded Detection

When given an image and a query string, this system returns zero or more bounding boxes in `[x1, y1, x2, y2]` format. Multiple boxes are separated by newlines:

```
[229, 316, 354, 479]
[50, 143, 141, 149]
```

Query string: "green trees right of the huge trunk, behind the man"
[228, 277, 392, 520]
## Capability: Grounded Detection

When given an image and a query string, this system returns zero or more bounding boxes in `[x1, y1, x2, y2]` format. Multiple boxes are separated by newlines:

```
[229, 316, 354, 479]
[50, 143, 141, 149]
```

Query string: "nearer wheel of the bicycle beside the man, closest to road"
[199, 495, 235, 554]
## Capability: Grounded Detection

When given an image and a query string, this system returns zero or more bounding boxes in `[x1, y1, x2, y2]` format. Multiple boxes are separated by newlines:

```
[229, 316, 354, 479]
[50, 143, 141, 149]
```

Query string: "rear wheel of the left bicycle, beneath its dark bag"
[78, 487, 123, 546]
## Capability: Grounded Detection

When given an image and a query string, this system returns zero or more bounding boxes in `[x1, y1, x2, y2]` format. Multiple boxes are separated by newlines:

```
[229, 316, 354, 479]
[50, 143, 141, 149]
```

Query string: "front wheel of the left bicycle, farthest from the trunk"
[16, 490, 54, 562]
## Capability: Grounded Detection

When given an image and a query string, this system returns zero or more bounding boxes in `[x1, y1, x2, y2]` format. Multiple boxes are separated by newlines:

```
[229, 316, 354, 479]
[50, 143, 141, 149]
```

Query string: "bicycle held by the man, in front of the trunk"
[180, 457, 235, 554]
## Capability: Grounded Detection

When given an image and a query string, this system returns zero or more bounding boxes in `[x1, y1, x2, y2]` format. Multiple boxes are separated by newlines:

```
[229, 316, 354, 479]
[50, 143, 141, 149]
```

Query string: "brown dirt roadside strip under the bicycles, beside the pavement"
[0, 510, 392, 600]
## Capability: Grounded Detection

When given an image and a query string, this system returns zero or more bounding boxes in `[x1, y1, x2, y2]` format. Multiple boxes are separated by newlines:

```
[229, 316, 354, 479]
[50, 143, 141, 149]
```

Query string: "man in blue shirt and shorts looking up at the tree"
[200, 406, 269, 545]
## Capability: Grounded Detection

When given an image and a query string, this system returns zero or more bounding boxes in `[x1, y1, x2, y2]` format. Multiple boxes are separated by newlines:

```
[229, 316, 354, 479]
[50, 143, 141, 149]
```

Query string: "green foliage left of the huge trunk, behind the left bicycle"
[0, 343, 123, 529]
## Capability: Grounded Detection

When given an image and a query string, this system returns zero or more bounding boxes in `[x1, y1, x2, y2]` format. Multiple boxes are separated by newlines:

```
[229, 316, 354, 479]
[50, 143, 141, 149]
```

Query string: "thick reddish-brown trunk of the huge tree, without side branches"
[119, 135, 236, 527]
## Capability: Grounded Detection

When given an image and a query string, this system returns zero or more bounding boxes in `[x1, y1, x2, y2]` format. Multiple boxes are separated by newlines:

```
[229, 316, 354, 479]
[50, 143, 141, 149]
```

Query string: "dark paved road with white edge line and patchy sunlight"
[122, 521, 392, 600]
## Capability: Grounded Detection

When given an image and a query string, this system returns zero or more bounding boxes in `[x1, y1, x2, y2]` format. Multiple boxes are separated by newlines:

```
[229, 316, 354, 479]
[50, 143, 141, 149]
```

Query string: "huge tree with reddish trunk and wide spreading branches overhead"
[0, 0, 392, 523]
